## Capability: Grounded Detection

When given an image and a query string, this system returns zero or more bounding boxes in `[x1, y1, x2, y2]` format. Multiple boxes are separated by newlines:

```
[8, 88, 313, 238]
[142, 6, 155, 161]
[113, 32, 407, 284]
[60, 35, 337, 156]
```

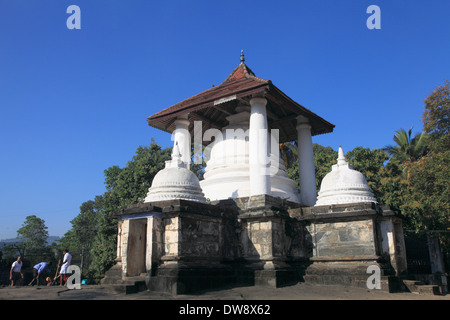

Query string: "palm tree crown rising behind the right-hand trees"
[383, 127, 428, 163]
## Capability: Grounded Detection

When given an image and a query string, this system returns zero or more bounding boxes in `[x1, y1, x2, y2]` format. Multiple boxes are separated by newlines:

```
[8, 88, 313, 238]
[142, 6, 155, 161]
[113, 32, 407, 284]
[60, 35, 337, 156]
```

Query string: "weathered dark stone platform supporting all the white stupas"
[105, 195, 404, 295]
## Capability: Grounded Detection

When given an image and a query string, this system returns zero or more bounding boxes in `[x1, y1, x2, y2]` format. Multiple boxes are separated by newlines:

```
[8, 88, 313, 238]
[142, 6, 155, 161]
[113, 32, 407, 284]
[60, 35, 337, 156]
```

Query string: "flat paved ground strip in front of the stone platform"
[0, 283, 450, 302]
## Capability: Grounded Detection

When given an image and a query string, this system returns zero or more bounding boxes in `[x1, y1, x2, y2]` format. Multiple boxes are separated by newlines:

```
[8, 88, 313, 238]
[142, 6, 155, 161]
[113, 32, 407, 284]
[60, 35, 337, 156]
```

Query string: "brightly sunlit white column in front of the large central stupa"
[249, 97, 270, 196]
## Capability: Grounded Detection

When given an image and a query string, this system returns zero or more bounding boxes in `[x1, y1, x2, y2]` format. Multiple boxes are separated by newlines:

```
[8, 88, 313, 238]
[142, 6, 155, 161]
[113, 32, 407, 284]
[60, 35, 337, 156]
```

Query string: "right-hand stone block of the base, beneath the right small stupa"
[290, 203, 406, 291]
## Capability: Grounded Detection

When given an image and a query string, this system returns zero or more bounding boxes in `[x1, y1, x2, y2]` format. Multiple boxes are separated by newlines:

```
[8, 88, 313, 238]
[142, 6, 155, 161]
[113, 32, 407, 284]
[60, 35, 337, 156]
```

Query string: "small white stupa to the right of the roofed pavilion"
[315, 146, 377, 206]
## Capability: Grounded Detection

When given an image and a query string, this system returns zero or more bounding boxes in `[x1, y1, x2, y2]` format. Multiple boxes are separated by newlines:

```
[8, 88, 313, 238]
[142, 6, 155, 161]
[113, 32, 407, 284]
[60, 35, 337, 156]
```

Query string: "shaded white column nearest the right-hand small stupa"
[297, 116, 317, 206]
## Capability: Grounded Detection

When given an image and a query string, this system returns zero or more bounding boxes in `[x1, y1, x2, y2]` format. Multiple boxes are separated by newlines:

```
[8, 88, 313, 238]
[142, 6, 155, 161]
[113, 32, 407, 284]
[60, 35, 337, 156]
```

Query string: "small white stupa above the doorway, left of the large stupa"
[144, 143, 206, 203]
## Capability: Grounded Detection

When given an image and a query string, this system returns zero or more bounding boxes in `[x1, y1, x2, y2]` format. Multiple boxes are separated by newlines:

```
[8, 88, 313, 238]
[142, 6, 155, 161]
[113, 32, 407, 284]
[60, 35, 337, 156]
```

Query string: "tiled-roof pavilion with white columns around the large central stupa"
[148, 53, 334, 205]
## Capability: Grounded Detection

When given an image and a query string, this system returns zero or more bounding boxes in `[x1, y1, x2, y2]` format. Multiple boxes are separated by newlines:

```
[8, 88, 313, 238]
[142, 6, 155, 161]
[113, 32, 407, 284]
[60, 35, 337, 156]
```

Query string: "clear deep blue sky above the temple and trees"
[0, 0, 450, 239]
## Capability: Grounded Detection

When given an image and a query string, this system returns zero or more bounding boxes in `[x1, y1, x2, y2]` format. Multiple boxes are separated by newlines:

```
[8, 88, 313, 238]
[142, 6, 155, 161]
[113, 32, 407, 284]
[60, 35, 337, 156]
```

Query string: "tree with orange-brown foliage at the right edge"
[402, 81, 450, 251]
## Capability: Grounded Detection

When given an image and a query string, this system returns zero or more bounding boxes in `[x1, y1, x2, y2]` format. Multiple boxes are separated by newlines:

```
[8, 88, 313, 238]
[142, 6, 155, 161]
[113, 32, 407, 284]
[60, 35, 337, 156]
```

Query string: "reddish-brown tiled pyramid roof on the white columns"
[147, 60, 334, 142]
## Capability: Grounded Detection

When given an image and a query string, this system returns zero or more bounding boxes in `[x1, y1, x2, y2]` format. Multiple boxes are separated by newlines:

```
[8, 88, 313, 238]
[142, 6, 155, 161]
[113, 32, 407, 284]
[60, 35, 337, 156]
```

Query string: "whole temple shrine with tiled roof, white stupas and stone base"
[102, 52, 406, 294]
